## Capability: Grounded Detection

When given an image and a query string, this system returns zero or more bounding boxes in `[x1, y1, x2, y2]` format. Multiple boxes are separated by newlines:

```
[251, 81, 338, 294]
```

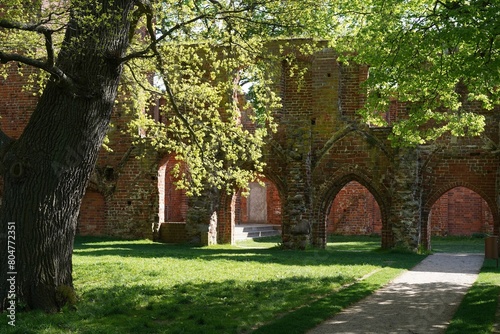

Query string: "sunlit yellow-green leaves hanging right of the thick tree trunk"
[121, 1, 334, 194]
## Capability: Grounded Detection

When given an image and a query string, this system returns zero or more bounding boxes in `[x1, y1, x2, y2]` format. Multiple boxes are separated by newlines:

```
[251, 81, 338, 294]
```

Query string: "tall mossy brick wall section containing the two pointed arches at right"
[266, 43, 499, 249]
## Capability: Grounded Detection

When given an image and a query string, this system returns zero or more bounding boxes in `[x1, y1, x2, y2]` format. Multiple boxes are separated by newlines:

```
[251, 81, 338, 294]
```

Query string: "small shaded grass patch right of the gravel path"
[446, 260, 500, 334]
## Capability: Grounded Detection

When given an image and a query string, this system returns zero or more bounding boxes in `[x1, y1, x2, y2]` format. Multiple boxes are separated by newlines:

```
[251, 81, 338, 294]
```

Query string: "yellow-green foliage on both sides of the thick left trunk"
[0, 0, 336, 194]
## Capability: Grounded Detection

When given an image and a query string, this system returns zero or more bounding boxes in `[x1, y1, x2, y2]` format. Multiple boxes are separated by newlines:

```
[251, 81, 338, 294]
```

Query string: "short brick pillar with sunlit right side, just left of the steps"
[186, 189, 219, 246]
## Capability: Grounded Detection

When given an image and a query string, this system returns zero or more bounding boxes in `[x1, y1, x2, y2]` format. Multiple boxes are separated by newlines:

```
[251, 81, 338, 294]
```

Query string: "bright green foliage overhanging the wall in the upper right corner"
[333, 0, 500, 146]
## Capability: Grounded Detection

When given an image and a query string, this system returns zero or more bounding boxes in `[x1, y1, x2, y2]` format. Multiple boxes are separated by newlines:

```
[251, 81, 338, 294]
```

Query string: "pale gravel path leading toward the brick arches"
[308, 253, 484, 334]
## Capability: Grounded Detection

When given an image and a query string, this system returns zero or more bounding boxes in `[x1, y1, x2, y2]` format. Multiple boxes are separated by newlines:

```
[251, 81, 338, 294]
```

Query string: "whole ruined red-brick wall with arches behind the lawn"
[0, 41, 500, 250]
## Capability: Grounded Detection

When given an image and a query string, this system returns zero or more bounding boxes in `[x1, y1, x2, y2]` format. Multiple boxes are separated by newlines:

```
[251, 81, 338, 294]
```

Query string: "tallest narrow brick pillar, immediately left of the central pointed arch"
[275, 56, 314, 249]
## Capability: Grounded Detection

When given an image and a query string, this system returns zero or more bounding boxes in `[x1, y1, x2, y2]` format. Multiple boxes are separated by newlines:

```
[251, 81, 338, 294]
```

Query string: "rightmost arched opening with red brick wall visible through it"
[429, 187, 494, 236]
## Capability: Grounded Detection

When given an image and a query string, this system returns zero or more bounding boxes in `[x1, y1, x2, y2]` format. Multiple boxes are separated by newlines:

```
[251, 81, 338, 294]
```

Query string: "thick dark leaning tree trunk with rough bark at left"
[0, 0, 134, 311]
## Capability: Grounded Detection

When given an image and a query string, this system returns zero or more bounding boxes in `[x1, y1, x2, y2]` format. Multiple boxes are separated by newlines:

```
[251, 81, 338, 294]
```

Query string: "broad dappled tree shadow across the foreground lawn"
[0, 276, 373, 334]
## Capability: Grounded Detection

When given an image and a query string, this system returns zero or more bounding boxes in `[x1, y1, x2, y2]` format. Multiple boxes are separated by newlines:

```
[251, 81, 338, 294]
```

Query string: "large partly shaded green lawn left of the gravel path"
[0, 238, 423, 333]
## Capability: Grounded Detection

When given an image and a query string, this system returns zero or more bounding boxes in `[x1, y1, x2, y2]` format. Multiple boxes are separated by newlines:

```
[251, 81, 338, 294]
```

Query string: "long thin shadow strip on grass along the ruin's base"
[74, 237, 423, 268]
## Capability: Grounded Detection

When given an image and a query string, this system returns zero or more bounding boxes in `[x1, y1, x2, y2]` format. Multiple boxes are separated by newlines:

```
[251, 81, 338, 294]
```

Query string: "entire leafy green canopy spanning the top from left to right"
[0, 0, 500, 197]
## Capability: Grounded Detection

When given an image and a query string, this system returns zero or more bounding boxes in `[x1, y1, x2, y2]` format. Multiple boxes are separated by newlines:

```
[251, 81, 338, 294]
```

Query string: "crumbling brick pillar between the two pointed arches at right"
[386, 149, 422, 251]
